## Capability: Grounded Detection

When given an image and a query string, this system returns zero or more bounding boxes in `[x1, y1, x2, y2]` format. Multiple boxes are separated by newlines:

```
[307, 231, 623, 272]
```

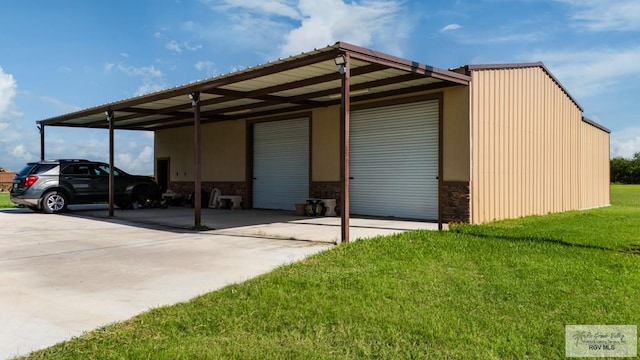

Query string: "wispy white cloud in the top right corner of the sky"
[557, 0, 640, 31]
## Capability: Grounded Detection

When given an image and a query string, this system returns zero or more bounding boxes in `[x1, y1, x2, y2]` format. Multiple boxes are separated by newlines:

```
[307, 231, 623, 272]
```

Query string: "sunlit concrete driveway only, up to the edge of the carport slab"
[0, 209, 332, 359]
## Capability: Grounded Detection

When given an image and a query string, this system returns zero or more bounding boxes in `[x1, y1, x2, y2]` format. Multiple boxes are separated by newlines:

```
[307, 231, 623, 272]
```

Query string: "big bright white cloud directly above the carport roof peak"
[201, 0, 404, 58]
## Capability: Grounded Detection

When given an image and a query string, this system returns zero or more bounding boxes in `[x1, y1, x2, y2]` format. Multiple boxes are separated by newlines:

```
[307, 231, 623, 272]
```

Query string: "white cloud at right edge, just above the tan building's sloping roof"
[526, 46, 640, 97]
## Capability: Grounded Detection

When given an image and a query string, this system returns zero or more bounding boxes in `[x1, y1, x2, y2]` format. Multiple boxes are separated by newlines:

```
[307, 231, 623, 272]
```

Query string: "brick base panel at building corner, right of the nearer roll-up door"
[440, 181, 471, 223]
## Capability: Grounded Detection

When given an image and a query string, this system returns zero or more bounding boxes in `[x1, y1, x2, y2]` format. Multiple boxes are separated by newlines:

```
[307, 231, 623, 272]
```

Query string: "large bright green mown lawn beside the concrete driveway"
[20, 186, 640, 359]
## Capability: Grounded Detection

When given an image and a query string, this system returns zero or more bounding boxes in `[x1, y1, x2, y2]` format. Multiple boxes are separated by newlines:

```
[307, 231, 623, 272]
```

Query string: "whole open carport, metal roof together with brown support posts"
[38, 42, 470, 242]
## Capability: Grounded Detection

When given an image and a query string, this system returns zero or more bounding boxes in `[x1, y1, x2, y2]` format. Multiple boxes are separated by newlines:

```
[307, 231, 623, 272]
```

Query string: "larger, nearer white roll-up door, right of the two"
[349, 100, 439, 220]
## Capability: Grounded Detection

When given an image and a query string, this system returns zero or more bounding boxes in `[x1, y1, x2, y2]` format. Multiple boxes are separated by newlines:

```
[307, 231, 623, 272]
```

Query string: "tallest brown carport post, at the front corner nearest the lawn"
[340, 53, 351, 243]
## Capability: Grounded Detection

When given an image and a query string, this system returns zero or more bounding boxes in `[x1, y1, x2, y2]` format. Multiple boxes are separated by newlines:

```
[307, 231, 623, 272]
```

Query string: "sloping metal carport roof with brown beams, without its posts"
[38, 42, 470, 130]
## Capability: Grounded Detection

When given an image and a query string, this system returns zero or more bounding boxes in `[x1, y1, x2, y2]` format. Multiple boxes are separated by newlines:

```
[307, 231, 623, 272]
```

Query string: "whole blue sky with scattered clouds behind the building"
[0, 0, 640, 174]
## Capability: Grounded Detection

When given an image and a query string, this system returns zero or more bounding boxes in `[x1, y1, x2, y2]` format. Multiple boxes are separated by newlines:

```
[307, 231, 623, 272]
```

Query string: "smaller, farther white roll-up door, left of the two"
[253, 118, 309, 210]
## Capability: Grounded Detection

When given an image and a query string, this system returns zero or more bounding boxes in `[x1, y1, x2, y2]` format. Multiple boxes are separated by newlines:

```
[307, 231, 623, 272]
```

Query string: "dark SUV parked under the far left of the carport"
[10, 159, 159, 214]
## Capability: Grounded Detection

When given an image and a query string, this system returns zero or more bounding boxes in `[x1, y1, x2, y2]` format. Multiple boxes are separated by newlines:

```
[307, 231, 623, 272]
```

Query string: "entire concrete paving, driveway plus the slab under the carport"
[0, 205, 437, 360]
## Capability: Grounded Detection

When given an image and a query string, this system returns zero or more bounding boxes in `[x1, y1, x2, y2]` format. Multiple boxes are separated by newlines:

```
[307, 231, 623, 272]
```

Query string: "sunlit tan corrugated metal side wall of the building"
[471, 67, 608, 223]
